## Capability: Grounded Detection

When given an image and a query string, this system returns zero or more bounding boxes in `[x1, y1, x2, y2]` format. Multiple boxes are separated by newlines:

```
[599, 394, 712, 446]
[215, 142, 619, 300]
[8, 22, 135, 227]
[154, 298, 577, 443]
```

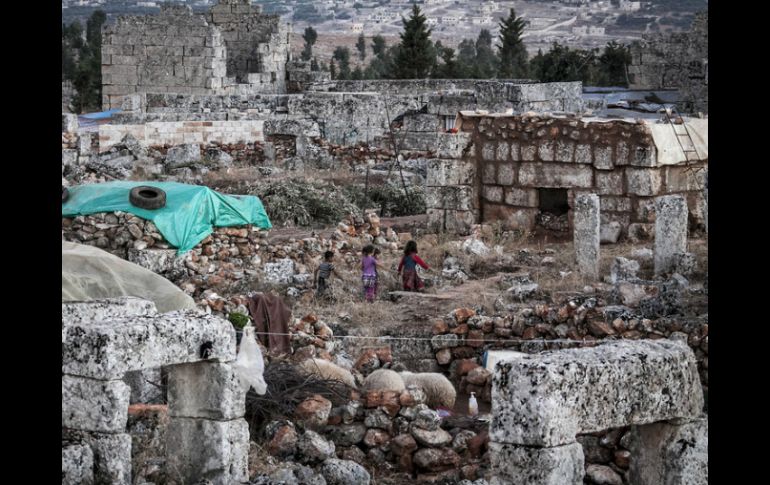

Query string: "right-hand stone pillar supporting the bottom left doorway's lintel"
[166, 362, 249, 485]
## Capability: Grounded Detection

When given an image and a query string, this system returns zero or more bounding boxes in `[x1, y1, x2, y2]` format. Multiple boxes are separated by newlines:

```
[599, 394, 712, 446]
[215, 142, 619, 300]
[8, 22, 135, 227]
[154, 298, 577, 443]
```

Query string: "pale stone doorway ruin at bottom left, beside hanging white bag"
[62, 298, 244, 485]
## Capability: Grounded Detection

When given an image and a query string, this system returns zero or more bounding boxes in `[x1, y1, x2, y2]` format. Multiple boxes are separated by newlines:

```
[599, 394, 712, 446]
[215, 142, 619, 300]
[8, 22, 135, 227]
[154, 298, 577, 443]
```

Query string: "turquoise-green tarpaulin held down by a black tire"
[61, 182, 272, 254]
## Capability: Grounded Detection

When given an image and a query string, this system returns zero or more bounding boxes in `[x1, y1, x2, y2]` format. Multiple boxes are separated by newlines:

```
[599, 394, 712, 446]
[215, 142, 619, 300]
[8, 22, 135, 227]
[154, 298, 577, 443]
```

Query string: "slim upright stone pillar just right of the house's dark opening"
[574, 194, 601, 279]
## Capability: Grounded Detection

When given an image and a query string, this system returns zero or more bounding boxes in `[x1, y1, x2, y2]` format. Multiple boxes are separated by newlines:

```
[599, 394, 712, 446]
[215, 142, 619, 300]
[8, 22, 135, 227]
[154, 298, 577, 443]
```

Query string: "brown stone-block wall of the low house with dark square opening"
[428, 116, 708, 239]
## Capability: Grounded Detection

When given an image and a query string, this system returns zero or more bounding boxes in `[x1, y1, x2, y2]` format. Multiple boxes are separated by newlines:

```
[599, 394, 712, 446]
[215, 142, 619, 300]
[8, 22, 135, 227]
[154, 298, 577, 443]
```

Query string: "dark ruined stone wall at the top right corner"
[628, 11, 708, 113]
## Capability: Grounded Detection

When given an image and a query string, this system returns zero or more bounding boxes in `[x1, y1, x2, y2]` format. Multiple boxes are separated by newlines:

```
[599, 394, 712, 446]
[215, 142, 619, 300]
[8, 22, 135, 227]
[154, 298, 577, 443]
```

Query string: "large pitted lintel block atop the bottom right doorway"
[490, 340, 703, 446]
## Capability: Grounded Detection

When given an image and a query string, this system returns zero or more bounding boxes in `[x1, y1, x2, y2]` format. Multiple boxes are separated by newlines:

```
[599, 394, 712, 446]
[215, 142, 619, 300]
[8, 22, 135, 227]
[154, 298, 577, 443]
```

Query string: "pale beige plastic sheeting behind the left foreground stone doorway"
[61, 241, 196, 313]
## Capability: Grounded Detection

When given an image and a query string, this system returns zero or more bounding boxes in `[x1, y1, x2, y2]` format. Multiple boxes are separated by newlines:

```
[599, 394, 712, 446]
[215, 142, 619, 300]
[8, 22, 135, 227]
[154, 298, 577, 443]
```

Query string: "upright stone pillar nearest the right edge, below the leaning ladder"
[655, 195, 687, 275]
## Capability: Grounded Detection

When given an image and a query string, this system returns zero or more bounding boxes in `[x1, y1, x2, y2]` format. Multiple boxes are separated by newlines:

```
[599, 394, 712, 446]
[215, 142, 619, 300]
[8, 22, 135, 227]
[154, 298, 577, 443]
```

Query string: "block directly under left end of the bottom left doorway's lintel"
[61, 375, 131, 433]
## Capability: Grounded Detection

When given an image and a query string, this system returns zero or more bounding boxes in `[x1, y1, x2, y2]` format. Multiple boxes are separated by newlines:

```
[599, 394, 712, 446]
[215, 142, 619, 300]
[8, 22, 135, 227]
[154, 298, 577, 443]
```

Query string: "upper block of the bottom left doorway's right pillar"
[168, 362, 246, 420]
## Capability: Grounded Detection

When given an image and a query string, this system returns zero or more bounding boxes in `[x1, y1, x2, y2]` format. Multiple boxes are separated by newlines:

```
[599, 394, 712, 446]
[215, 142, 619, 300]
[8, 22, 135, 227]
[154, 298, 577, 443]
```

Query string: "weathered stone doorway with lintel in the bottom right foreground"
[490, 340, 708, 485]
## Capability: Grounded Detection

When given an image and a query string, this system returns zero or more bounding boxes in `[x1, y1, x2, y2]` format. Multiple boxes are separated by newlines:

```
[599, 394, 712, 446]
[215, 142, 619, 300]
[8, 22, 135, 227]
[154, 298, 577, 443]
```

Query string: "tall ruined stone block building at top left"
[102, 0, 291, 109]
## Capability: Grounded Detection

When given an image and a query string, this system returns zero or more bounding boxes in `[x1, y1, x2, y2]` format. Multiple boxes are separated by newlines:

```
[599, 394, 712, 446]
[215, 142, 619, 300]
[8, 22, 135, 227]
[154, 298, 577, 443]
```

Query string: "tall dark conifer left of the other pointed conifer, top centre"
[393, 4, 436, 79]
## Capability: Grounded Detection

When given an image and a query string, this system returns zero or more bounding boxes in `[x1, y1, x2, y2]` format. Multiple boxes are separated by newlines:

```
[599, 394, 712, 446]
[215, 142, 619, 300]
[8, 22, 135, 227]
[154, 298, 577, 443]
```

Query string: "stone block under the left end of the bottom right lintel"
[489, 442, 585, 485]
